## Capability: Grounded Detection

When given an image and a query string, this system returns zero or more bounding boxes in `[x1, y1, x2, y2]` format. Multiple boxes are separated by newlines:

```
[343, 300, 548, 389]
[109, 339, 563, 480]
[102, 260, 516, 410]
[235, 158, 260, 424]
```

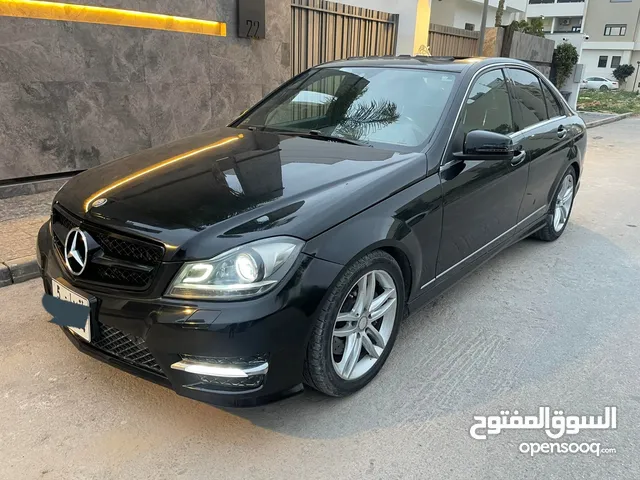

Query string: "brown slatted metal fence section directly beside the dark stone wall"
[291, 0, 398, 75]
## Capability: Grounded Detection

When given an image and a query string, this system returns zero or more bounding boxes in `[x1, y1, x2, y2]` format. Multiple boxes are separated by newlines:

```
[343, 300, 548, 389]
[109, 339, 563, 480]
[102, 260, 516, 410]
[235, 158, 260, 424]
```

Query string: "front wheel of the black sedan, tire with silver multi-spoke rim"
[303, 250, 405, 397]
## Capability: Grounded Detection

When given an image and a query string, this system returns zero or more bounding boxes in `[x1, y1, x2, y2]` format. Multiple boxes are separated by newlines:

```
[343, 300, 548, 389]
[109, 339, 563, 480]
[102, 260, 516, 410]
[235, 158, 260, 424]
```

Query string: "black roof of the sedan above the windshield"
[316, 55, 531, 72]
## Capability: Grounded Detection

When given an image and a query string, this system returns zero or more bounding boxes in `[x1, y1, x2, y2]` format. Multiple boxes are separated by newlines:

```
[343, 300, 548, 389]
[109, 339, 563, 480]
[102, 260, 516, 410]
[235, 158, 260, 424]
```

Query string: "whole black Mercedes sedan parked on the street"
[38, 57, 586, 406]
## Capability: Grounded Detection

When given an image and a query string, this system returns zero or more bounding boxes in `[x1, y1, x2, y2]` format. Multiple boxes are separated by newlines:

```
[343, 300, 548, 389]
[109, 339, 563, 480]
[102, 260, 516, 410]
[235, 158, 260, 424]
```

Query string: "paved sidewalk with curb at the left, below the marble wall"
[0, 192, 55, 287]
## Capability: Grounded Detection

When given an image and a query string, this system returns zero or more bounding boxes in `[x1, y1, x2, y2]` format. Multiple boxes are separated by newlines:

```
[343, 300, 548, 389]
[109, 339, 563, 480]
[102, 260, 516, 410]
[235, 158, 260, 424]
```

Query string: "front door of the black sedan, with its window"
[436, 68, 528, 275]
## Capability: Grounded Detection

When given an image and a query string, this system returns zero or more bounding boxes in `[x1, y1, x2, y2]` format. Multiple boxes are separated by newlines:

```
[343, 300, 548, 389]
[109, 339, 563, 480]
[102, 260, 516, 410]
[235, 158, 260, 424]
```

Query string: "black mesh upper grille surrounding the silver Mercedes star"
[51, 206, 164, 289]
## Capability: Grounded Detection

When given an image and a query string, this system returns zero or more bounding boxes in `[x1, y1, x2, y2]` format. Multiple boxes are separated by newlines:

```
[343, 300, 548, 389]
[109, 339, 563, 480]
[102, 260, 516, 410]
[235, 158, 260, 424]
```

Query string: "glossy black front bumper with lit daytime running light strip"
[38, 222, 342, 407]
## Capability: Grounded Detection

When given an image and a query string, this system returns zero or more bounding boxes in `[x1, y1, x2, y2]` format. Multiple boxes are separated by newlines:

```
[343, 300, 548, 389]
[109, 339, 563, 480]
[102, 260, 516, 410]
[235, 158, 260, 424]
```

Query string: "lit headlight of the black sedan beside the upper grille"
[167, 237, 304, 300]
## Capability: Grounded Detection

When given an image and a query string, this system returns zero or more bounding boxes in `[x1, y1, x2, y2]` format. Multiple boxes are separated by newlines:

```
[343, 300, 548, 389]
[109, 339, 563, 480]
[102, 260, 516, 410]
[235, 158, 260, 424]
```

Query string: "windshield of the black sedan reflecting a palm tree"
[237, 67, 456, 148]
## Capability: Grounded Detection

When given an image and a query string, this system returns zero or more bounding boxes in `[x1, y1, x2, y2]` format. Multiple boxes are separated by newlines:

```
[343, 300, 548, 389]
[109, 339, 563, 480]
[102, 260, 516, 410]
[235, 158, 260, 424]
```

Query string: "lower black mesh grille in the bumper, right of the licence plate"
[91, 322, 165, 377]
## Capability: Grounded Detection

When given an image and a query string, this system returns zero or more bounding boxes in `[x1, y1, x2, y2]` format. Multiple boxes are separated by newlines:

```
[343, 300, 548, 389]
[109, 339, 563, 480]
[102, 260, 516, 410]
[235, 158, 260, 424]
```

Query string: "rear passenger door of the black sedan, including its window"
[507, 68, 573, 229]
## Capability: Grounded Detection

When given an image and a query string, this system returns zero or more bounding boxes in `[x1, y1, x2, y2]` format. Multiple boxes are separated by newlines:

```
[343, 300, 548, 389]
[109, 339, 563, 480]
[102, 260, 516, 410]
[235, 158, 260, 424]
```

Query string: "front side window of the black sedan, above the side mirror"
[461, 70, 514, 135]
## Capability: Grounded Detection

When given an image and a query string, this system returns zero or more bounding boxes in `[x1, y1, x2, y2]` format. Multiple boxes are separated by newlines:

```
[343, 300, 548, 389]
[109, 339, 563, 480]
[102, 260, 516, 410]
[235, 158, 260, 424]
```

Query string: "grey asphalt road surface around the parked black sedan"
[0, 119, 640, 479]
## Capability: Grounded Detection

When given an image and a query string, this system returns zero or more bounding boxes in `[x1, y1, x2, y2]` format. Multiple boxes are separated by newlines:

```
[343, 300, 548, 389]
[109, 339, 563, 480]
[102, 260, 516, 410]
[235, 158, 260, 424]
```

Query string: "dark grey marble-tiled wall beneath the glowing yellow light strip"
[0, 0, 291, 184]
